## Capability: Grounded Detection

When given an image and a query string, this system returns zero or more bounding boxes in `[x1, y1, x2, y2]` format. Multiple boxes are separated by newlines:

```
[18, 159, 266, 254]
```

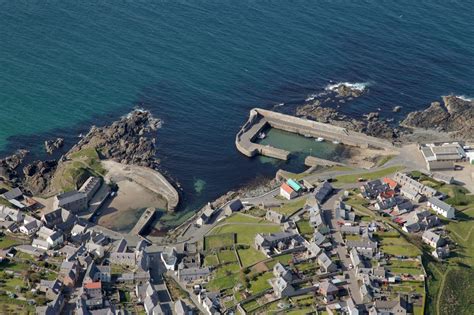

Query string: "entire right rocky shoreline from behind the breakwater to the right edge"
[294, 84, 474, 143]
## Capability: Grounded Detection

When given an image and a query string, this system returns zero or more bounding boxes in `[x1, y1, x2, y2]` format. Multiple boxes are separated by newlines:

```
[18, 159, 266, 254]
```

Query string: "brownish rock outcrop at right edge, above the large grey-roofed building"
[401, 95, 474, 139]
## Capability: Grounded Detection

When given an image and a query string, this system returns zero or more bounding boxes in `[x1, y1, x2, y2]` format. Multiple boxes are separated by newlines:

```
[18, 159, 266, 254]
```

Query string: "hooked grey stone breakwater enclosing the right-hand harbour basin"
[235, 108, 394, 161]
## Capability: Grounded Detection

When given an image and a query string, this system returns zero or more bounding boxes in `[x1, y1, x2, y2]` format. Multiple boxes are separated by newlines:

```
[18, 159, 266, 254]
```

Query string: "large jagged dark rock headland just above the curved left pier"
[68, 111, 161, 168]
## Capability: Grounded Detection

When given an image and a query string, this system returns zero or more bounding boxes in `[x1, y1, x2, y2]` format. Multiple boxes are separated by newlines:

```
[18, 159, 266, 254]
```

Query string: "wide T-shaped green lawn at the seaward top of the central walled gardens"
[211, 223, 281, 246]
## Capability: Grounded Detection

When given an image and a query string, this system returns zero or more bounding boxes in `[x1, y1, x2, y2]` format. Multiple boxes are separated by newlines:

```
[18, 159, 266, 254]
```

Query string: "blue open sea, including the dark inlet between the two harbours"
[0, 0, 474, 226]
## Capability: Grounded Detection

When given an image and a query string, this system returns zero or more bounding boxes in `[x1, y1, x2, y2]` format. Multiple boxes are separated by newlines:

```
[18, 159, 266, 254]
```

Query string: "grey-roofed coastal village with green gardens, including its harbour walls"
[0, 102, 474, 315]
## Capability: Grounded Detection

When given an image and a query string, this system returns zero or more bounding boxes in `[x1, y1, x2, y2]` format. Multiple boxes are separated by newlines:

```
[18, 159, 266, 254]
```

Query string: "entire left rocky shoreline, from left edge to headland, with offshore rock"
[0, 110, 174, 195]
